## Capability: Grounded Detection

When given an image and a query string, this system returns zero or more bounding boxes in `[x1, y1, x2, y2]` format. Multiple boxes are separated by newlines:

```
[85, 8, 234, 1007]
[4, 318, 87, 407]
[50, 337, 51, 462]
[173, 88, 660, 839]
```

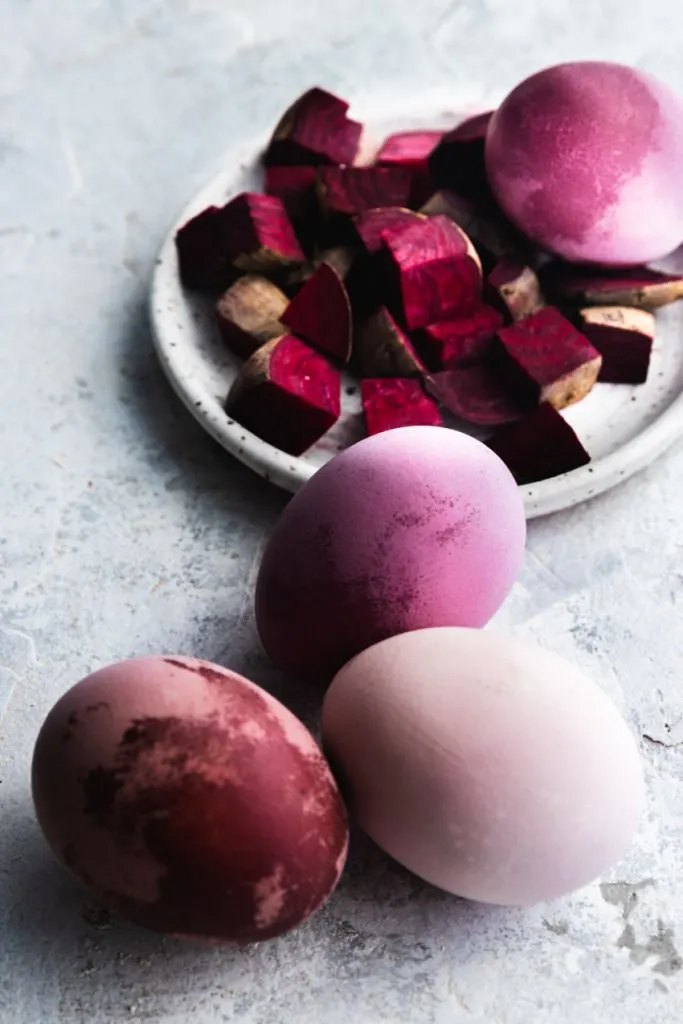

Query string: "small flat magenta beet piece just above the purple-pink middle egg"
[360, 377, 443, 434]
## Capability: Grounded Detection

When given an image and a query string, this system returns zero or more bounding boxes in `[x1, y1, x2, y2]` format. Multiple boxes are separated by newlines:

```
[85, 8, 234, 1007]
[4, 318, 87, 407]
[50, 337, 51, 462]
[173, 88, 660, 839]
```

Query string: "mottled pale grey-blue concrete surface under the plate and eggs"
[0, 0, 683, 1024]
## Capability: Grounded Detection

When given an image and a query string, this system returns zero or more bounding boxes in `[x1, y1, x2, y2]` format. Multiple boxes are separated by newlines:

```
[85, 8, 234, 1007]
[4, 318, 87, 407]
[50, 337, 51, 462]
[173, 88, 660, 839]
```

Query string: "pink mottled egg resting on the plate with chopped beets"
[486, 61, 683, 266]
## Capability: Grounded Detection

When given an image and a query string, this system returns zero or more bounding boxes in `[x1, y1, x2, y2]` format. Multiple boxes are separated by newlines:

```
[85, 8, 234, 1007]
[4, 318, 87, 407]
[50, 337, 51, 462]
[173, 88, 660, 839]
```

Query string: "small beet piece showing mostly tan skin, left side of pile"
[216, 273, 289, 359]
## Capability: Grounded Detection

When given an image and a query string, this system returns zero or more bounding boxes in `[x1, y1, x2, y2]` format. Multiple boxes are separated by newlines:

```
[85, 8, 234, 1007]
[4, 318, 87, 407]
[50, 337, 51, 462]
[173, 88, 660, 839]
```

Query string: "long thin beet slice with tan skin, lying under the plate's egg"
[541, 262, 683, 309]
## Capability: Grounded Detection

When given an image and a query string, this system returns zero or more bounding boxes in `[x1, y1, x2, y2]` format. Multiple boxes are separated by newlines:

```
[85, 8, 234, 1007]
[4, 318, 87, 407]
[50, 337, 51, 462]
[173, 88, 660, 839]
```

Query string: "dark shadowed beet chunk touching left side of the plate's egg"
[428, 111, 494, 199]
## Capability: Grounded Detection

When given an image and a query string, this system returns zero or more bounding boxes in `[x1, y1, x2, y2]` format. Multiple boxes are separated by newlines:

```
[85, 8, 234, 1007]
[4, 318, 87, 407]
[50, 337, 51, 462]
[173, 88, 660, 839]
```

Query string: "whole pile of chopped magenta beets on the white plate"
[176, 89, 683, 483]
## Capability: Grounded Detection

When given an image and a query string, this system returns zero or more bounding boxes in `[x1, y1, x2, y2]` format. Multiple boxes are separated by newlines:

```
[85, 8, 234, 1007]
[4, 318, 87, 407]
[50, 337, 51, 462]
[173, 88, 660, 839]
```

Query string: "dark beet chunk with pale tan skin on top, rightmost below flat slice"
[579, 306, 654, 384]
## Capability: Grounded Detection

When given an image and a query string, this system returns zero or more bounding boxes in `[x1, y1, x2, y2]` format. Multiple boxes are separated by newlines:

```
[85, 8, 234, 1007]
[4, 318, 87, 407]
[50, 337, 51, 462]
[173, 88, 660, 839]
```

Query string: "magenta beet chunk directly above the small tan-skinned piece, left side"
[223, 193, 305, 273]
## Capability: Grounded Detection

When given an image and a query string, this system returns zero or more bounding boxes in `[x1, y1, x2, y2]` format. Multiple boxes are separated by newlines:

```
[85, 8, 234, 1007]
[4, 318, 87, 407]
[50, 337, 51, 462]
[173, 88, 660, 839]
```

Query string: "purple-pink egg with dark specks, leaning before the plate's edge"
[256, 427, 525, 682]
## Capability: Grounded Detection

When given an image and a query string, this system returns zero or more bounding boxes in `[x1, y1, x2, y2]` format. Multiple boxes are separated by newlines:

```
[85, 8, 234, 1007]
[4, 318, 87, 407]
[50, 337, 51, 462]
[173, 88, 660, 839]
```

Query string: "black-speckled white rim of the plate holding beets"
[150, 96, 683, 519]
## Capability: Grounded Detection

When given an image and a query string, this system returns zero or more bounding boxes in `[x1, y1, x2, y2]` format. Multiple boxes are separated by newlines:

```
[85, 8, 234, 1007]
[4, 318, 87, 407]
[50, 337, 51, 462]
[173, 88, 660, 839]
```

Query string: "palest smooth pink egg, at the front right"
[323, 629, 643, 904]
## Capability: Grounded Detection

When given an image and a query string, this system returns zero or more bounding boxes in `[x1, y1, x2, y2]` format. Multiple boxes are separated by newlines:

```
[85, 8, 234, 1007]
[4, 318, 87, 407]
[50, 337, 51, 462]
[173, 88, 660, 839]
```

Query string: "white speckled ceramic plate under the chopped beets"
[151, 102, 683, 518]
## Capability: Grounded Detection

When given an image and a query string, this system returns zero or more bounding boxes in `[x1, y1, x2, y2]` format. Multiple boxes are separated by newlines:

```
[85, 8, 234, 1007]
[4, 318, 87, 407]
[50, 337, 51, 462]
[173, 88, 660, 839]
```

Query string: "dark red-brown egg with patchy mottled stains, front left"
[33, 657, 347, 942]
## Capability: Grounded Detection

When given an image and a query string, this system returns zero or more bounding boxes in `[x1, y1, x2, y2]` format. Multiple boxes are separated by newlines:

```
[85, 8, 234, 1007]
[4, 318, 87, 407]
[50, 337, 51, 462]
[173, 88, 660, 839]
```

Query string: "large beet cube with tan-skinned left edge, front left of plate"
[225, 335, 341, 455]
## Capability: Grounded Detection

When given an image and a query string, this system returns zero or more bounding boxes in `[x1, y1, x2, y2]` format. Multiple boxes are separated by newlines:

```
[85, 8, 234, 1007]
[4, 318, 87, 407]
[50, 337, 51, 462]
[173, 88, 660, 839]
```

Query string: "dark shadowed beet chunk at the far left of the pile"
[175, 206, 233, 292]
